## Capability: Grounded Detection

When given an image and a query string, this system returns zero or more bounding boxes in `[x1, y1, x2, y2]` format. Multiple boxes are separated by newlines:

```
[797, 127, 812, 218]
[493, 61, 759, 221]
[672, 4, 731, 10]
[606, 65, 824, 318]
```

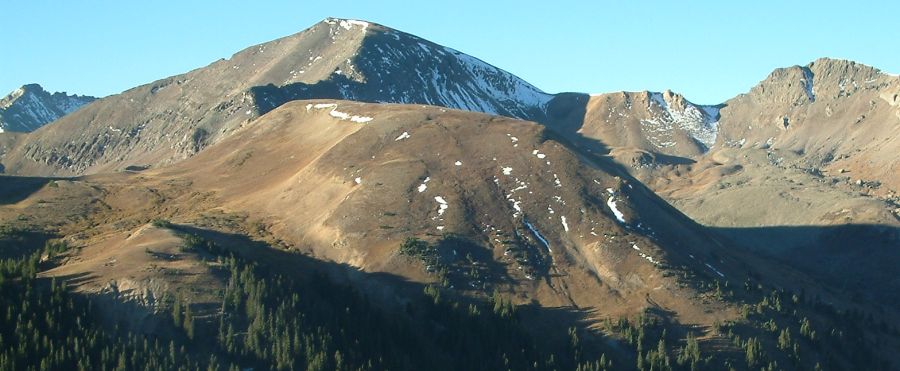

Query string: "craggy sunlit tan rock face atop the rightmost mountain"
[717, 58, 900, 190]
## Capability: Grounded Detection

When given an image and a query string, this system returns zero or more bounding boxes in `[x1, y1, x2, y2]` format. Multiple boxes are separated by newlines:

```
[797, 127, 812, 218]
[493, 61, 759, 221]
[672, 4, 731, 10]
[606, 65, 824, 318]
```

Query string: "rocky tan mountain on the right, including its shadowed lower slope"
[576, 58, 900, 310]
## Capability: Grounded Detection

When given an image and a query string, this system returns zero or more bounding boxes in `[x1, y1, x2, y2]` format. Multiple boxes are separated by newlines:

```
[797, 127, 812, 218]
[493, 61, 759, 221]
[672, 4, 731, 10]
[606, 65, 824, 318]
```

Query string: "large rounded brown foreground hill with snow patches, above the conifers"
[0, 99, 896, 368]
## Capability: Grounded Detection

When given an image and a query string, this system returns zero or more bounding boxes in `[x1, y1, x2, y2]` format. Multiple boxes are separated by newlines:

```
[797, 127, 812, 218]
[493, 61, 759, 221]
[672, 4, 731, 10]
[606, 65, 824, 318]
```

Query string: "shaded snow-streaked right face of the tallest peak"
[250, 32, 546, 122]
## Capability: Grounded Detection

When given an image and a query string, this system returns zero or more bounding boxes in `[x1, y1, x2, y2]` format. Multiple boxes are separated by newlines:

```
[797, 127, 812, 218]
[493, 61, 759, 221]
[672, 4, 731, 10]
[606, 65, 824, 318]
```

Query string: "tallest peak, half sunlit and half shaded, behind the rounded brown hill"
[2, 19, 552, 175]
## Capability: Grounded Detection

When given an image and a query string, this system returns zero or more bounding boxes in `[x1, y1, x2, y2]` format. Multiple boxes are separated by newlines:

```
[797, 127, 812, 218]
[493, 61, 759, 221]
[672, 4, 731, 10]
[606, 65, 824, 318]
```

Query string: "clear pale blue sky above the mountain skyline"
[0, 0, 900, 103]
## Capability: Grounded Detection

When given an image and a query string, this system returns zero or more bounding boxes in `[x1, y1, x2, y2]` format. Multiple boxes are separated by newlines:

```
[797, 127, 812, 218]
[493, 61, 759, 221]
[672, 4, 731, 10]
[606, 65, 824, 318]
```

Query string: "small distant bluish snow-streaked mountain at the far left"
[0, 84, 97, 133]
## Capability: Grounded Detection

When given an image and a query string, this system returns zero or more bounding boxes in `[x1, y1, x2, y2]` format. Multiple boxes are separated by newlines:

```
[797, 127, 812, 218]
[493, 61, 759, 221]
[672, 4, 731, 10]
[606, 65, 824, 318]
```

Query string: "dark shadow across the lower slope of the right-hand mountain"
[709, 224, 900, 308]
